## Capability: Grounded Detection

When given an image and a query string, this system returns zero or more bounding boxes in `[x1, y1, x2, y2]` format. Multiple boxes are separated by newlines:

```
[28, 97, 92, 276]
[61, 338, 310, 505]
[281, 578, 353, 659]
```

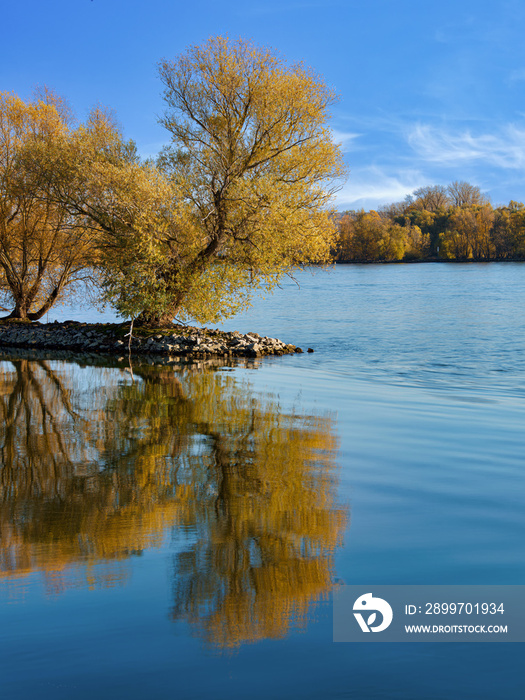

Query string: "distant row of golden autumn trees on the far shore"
[334, 182, 525, 262]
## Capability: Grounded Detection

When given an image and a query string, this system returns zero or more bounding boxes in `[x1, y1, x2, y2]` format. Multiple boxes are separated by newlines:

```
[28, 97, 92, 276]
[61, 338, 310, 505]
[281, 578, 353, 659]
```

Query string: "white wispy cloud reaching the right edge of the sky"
[407, 124, 525, 169]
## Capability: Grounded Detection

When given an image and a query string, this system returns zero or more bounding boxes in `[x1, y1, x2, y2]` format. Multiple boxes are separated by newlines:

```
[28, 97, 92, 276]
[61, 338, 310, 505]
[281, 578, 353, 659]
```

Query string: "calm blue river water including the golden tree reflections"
[0, 264, 525, 700]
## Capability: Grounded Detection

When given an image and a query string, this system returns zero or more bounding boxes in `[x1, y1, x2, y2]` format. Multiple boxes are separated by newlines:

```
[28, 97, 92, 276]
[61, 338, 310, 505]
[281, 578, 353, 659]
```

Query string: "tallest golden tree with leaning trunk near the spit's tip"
[110, 37, 343, 323]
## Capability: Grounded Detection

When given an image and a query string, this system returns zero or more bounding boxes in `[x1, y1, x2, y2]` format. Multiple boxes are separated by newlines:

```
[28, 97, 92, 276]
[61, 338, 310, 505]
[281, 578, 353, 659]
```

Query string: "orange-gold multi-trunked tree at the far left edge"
[0, 90, 102, 320]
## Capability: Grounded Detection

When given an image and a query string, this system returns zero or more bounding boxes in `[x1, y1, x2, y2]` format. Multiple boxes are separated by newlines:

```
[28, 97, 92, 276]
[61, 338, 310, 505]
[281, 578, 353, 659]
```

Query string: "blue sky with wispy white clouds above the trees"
[0, 0, 525, 209]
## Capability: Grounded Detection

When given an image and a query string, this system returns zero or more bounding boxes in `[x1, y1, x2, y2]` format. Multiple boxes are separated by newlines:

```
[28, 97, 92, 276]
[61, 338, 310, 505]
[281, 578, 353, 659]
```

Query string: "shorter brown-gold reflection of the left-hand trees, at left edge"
[0, 360, 189, 590]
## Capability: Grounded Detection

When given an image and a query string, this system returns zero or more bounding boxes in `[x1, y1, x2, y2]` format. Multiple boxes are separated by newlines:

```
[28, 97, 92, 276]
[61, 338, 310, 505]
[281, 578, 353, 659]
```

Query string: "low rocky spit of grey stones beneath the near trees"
[0, 321, 313, 358]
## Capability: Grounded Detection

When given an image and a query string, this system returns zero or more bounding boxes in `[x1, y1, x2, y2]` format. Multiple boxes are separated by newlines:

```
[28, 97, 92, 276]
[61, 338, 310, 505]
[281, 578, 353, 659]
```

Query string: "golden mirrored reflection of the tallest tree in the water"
[172, 406, 346, 646]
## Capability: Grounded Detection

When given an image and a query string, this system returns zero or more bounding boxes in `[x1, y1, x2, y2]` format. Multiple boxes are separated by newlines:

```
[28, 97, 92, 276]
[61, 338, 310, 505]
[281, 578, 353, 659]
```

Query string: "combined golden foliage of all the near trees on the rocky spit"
[0, 37, 344, 323]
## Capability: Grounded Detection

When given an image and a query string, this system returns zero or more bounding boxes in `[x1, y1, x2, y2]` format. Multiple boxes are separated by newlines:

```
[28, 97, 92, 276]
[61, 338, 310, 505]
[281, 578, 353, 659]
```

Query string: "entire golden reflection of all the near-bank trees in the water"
[0, 357, 347, 647]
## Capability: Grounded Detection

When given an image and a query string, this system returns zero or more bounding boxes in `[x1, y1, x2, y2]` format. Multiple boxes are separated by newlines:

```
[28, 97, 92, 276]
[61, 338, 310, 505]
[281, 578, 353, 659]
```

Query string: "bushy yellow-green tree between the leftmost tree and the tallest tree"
[26, 108, 172, 317]
